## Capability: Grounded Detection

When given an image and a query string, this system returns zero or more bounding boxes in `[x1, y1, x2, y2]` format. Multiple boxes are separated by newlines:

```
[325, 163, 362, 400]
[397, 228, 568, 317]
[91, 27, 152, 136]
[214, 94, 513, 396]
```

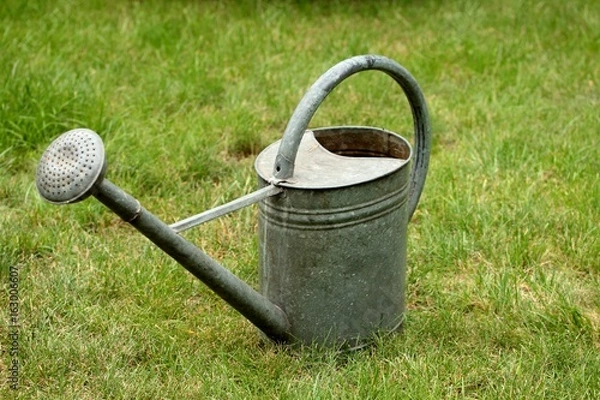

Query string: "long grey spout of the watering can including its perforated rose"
[36, 129, 289, 341]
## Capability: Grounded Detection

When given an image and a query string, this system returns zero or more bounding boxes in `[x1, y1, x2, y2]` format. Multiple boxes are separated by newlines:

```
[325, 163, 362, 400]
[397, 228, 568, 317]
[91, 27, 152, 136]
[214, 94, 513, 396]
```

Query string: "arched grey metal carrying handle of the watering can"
[273, 55, 431, 219]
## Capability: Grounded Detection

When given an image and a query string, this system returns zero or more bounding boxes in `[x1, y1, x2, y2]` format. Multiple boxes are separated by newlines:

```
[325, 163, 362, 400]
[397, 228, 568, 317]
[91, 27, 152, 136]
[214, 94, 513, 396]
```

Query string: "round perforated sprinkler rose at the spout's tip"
[35, 128, 106, 204]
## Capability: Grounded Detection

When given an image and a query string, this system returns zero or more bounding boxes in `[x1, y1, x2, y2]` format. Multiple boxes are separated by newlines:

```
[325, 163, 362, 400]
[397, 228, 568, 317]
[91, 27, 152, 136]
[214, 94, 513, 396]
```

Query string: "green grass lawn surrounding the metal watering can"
[0, 0, 600, 399]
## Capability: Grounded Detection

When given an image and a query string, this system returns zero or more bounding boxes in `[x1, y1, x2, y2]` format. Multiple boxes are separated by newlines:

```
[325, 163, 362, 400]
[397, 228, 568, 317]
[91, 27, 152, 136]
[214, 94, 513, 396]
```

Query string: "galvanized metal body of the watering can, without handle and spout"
[256, 127, 411, 347]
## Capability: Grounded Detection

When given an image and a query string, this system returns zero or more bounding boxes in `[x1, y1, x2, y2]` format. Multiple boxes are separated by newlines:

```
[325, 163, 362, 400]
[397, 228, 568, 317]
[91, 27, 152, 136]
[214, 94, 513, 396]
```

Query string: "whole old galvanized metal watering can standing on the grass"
[36, 55, 430, 347]
